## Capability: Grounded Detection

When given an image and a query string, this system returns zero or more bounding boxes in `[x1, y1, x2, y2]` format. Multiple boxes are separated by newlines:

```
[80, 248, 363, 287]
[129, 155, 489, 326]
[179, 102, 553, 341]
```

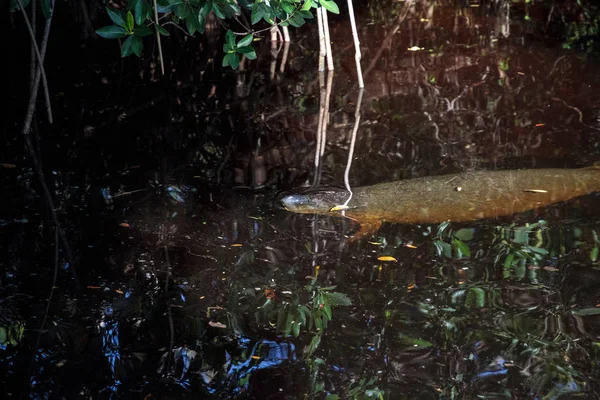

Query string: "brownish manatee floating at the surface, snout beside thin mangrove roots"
[281, 166, 600, 236]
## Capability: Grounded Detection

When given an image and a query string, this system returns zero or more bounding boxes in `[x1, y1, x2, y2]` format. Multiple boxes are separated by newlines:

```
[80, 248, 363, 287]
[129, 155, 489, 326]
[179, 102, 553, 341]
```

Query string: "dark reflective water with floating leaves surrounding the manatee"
[0, 1, 600, 399]
